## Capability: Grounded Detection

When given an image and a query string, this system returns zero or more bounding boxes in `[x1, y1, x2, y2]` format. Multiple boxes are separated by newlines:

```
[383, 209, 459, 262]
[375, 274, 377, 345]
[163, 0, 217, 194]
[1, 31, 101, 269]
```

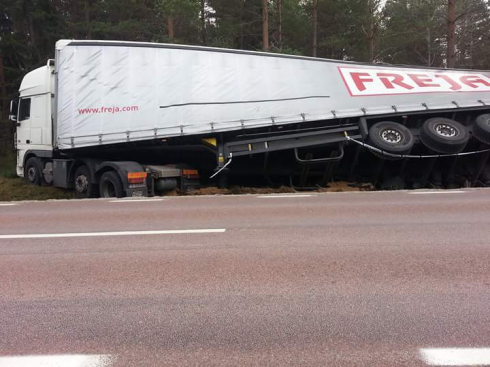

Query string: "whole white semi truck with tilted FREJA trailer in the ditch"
[6, 40, 490, 198]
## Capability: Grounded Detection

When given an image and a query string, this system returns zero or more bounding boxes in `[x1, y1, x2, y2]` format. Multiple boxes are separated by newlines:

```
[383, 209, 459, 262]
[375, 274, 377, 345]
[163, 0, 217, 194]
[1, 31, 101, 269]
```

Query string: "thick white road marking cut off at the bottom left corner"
[0, 354, 113, 367]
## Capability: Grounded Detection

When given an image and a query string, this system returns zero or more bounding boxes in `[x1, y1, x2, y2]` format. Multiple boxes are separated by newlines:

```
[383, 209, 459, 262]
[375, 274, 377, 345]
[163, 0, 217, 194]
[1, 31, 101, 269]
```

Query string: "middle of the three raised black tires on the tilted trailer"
[420, 117, 470, 154]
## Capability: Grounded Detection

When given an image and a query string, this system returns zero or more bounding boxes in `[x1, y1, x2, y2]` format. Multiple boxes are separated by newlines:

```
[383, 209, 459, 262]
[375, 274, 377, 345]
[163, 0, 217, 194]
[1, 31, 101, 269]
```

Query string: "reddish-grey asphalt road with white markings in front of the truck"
[0, 190, 490, 367]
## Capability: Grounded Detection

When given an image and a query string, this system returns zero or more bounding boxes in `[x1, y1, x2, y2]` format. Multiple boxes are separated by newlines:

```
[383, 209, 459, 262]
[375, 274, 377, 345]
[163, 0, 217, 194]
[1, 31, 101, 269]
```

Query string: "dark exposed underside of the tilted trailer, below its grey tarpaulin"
[28, 107, 490, 194]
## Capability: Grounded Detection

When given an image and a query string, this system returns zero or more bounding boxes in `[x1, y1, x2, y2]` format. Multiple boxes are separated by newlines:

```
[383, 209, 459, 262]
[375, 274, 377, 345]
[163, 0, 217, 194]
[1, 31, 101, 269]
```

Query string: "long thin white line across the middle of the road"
[0, 229, 226, 240]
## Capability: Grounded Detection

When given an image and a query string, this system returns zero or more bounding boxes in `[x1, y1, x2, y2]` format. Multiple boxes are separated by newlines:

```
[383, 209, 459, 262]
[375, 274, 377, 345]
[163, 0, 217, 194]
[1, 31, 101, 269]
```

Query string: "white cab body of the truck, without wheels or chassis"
[11, 60, 55, 177]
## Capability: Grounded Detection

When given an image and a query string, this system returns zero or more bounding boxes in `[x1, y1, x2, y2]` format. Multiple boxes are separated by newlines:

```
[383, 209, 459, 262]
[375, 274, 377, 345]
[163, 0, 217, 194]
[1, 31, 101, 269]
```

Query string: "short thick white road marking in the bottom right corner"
[420, 348, 490, 366]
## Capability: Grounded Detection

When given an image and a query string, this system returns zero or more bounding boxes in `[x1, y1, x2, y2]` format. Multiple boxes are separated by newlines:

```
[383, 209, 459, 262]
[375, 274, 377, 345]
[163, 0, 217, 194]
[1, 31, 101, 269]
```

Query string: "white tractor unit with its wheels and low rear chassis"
[9, 45, 193, 198]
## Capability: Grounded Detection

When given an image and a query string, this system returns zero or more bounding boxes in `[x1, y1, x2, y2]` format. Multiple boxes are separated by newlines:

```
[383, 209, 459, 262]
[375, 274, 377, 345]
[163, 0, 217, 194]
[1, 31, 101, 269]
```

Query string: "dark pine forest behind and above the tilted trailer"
[0, 0, 490, 108]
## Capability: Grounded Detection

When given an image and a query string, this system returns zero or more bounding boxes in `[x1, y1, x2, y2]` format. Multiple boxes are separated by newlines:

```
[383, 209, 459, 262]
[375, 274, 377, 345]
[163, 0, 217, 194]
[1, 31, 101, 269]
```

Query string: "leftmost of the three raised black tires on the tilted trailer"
[369, 121, 415, 160]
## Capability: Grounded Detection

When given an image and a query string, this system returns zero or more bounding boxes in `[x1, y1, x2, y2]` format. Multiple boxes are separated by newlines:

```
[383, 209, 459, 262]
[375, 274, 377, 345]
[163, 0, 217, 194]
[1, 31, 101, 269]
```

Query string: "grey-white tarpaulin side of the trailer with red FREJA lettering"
[55, 41, 490, 149]
